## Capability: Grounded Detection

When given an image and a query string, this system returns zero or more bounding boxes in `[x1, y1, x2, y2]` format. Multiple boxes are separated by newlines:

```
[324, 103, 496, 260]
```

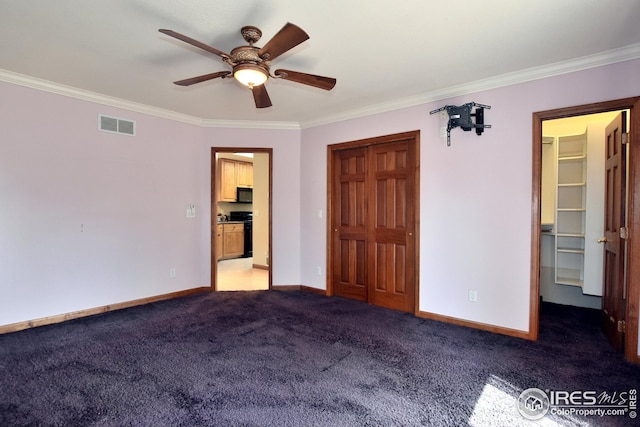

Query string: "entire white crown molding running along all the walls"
[0, 43, 640, 130]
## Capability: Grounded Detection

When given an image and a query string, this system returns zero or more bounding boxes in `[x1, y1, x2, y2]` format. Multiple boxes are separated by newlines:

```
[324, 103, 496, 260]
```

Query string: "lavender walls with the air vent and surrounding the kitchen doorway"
[0, 79, 301, 325]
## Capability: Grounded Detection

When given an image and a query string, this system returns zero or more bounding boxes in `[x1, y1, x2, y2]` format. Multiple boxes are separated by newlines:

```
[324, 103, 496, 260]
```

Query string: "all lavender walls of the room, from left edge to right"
[0, 57, 640, 352]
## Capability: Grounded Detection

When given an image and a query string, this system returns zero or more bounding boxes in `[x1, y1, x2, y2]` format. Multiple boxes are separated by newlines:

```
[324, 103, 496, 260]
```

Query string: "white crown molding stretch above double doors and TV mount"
[300, 43, 640, 129]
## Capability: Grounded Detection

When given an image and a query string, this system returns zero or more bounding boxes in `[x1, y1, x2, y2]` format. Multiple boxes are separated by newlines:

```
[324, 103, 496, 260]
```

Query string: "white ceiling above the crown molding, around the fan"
[0, 0, 640, 124]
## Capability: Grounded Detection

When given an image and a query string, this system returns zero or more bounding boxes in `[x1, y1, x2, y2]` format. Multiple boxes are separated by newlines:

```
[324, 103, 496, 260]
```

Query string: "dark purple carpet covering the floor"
[0, 291, 640, 427]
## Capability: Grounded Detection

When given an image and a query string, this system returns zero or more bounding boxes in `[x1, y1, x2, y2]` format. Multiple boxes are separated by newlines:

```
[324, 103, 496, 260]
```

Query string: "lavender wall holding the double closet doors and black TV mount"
[301, 60, 640, 331]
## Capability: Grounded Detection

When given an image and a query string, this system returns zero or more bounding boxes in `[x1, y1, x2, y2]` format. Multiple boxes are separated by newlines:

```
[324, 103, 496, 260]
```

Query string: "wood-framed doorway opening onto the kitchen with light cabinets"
[211, 147, 273, 291]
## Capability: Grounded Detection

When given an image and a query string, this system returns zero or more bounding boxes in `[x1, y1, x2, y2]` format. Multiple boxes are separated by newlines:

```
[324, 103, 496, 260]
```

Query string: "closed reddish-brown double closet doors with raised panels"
[329, 133, 417, 313]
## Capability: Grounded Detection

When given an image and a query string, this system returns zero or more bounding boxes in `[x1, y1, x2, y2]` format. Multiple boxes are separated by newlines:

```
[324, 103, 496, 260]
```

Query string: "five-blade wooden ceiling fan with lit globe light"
[158, 22, 336, 108]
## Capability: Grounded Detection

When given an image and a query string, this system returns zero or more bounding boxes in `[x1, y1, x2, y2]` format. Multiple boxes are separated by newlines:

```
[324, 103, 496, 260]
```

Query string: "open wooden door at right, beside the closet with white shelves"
[601, 112, 626, 351]
